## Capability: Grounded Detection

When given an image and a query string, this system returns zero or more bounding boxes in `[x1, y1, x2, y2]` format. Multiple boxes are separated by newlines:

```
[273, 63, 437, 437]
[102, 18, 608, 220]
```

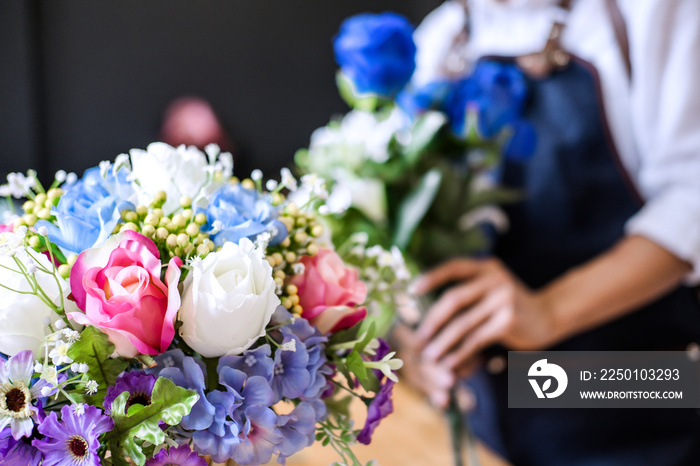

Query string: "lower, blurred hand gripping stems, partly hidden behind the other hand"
[394, 325, 456, 409]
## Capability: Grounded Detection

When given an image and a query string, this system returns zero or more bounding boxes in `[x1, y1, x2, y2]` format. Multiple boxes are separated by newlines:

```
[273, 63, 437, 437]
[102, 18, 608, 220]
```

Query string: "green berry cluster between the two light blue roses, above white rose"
[114, 191, 215, 260]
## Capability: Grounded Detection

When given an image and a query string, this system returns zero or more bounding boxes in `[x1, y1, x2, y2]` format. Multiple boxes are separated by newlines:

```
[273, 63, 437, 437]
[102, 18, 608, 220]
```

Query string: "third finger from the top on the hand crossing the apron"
[423, 293, 504, 362]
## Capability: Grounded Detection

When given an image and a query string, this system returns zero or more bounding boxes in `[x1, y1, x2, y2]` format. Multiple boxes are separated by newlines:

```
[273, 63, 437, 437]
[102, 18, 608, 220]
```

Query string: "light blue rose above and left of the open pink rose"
[36, 167, 134, 254]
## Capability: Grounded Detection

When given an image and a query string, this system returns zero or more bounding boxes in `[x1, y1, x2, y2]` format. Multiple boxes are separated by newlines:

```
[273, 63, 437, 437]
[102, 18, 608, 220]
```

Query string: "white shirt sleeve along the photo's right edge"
[620, 0, 700, 283]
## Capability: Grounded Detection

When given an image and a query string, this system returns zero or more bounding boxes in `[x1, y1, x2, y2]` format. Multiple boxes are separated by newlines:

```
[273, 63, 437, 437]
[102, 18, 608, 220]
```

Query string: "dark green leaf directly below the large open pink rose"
[68, 326, 129, 408]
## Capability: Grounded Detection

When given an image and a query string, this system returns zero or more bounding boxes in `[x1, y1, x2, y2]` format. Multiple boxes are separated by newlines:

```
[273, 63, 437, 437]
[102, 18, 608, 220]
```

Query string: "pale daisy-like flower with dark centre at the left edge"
[0, 351, 49, 440]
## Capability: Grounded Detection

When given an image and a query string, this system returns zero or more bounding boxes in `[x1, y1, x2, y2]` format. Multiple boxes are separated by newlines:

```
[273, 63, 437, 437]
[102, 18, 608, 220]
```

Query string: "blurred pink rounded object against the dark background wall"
[161, 97, 233, 151]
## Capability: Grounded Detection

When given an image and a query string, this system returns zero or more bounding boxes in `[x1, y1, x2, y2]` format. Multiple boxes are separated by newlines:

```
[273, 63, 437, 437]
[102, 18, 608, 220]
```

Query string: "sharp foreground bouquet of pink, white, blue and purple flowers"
[0, 143, 402, 466]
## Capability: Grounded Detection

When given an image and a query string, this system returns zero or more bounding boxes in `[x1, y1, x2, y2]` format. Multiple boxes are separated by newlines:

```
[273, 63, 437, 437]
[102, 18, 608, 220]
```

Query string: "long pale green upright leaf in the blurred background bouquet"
[394, 168, 442, 250]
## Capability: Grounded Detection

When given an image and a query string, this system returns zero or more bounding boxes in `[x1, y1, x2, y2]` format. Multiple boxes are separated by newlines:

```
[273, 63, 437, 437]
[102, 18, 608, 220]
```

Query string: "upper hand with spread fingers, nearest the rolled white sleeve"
[413, 259, 558, 376]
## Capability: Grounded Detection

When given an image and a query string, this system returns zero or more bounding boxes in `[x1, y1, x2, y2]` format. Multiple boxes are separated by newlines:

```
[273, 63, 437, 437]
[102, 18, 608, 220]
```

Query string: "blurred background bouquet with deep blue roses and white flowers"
[295, 13, 534, 268]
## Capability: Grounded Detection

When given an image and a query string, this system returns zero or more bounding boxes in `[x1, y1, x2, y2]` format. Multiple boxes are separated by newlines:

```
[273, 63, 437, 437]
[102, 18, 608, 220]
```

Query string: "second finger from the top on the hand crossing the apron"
[416, 275, 493, 346]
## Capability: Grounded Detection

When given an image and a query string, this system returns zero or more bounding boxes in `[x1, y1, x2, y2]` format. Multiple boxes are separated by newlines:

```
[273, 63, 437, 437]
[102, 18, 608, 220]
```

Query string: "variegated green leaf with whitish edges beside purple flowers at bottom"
[108, 377, 199, 466]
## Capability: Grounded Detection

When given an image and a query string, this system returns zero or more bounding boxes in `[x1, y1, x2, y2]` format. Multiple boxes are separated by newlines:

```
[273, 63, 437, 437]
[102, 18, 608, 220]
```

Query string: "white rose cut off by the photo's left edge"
[0, 242, 77, 357]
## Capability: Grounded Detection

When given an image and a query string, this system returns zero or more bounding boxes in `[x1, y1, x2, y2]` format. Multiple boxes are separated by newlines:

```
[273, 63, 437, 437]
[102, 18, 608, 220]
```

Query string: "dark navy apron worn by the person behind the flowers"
[468, 57, 700, 466]
